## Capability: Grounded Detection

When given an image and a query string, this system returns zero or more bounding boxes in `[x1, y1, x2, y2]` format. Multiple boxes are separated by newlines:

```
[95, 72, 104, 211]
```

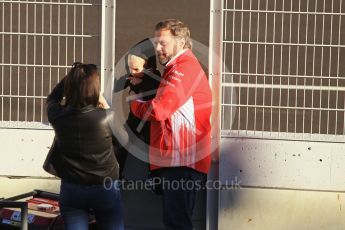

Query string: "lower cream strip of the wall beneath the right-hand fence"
[218, 188, 345, 230]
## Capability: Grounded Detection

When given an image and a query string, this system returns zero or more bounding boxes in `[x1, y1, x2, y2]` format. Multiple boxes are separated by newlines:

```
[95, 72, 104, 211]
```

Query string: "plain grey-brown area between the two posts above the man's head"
[115, 0, 210, 62]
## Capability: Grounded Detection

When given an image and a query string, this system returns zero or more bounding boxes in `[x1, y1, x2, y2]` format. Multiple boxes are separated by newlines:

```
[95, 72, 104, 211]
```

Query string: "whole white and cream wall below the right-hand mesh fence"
[216, 138, 345, 230]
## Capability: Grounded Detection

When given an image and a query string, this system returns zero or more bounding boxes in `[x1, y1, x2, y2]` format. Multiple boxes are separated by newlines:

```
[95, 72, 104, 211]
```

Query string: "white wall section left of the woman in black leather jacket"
[0, 124, 60, 198]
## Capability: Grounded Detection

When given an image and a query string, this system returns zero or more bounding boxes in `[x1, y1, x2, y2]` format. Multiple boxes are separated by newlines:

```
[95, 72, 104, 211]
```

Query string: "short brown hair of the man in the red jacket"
[155, 19, 192, 49]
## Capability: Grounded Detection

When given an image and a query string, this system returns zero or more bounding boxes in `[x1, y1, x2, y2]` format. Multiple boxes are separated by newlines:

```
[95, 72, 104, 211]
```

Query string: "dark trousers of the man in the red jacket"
[155, 167, 206, 230]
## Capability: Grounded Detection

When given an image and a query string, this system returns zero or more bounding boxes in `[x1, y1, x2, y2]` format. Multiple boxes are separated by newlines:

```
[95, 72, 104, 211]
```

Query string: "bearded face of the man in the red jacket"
[154, 30, 184, 65]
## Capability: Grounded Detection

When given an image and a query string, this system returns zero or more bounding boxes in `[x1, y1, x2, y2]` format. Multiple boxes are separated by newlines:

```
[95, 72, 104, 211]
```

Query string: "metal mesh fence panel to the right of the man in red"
[221, 0, 345, 142]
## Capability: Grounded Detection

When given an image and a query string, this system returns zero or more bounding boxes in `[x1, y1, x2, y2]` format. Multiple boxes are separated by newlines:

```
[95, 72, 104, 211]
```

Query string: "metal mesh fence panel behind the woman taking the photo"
[0, 0, 101, 127]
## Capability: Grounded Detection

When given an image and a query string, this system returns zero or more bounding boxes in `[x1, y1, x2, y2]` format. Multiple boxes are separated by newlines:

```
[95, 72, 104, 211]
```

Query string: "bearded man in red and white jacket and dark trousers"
[131, 19, 212, 229]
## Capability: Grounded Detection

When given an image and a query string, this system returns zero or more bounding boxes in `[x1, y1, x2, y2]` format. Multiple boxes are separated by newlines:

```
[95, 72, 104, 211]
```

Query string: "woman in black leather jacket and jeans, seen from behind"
[47, 63, 123, 230]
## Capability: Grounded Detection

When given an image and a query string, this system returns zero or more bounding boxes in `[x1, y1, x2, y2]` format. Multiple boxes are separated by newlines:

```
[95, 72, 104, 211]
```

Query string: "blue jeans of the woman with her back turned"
[59, 180, 124, 230]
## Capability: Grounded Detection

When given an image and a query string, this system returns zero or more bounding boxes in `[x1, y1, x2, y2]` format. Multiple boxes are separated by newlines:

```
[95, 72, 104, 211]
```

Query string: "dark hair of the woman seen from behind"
[64, 62, 100, 108]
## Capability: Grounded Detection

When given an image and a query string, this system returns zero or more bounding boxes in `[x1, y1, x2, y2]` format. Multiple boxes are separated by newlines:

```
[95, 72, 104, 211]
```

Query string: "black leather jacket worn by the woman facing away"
[47, 80, 119, 185]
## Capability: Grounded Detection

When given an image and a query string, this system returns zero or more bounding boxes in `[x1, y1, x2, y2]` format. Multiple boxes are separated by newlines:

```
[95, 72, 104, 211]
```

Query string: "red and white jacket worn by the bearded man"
[131, 49, 212, 173]
